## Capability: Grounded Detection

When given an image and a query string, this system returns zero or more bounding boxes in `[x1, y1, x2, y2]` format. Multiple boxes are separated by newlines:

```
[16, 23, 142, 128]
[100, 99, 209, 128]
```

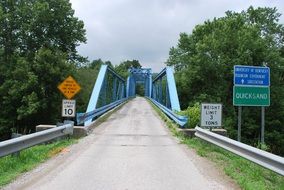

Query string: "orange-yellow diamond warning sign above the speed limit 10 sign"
[57, 76, 81, 99]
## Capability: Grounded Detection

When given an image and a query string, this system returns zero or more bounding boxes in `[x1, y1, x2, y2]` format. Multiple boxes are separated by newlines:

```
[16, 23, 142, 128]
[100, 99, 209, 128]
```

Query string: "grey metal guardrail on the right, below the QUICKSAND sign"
[195, 127, 284, 176]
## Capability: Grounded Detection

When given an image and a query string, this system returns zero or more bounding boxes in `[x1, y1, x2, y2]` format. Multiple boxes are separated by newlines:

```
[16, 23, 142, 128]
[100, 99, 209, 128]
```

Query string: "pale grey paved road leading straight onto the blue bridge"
[4, 98, 237, 190]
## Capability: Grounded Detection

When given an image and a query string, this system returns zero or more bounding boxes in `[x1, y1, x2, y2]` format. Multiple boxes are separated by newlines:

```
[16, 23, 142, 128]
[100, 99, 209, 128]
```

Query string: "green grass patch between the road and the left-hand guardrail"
[0, 138, 78, 188]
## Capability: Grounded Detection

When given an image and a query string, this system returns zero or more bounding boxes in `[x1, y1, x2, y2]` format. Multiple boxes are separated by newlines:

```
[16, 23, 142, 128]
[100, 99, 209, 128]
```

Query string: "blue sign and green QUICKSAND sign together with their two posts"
[233, 65, 270, 144]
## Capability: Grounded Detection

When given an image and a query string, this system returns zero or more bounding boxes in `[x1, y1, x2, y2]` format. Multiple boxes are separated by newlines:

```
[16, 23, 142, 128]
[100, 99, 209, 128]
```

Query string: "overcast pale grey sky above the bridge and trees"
[70, 0, 284, 72]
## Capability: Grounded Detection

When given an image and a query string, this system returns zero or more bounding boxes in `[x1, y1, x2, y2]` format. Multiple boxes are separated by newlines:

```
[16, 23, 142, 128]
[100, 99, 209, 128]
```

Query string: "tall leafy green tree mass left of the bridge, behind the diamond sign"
[0, 0, 86, 138]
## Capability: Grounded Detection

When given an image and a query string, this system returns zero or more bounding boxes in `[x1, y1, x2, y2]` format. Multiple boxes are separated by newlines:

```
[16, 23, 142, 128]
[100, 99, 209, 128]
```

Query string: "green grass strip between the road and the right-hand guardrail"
[149, 101, 284, 190]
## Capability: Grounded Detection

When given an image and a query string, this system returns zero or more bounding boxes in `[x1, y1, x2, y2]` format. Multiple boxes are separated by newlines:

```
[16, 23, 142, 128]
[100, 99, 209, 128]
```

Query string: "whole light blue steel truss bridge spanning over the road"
[77, 65, 187, 127]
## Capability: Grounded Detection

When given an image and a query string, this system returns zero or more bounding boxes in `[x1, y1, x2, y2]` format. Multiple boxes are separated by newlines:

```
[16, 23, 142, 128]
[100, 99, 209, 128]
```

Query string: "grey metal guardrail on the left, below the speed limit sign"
[0, 123, 74, 158]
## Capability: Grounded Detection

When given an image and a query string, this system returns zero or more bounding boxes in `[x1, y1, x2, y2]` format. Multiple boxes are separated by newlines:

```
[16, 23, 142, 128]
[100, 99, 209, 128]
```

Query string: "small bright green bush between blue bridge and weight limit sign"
[180, 103, 200, 128]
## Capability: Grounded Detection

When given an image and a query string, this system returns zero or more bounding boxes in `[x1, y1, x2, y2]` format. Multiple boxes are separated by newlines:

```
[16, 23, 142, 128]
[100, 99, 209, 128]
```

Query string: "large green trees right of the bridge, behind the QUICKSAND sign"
[167, 7, 284, 155]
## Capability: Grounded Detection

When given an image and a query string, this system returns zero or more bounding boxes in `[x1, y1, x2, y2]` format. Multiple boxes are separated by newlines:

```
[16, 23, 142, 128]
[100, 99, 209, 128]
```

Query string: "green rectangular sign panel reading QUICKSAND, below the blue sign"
[233, 86, 270, 106]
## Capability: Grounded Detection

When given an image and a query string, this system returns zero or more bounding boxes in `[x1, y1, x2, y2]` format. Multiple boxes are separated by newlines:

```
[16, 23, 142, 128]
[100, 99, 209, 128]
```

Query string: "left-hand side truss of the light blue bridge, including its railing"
[76, 65, 127, 126]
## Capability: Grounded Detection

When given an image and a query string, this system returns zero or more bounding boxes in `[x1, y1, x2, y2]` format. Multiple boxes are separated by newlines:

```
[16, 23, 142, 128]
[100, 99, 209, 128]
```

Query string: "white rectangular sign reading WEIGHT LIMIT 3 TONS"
[201, 103, 222, 127]
